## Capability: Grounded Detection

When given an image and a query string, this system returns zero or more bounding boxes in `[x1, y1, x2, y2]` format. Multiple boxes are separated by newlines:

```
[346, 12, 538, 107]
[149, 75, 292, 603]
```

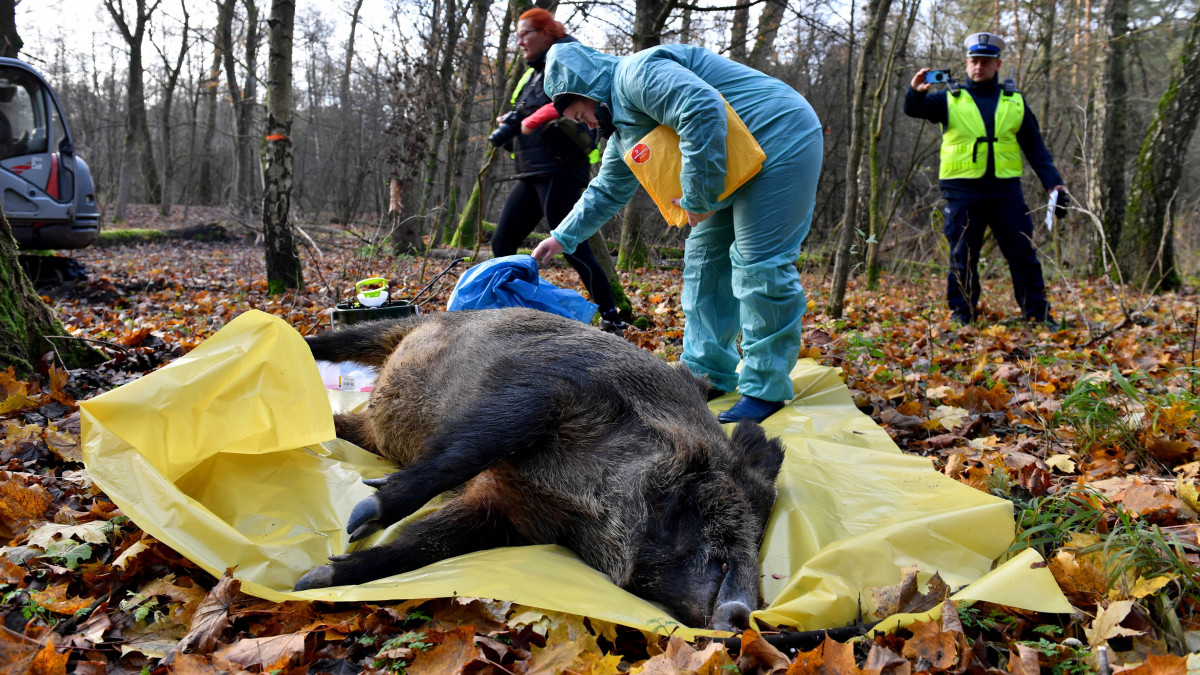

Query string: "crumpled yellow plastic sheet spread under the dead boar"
[80, 311, 1070, 638]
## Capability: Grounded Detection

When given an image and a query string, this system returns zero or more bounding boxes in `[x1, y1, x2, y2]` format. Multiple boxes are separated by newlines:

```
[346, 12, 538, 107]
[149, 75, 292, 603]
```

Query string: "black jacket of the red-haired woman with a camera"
[511, 35, 595, 183]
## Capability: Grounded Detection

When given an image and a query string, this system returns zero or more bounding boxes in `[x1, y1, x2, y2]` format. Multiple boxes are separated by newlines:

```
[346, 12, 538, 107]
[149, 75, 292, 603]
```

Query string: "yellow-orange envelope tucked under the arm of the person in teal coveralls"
[623, 98, 767, 227]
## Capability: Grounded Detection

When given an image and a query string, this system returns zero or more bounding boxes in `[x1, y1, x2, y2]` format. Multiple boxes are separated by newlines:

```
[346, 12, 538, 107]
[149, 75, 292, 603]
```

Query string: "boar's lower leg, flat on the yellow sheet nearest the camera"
[295, 496, 528, 591]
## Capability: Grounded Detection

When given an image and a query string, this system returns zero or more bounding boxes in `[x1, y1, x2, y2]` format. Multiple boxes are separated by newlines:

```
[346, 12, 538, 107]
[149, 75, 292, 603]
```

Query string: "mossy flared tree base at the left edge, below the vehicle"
[0, 209, 103, 377]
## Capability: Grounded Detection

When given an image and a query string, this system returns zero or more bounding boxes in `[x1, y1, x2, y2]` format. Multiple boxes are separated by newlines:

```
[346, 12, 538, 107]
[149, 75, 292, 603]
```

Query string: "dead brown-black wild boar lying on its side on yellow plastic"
[295, 309, 784, 631]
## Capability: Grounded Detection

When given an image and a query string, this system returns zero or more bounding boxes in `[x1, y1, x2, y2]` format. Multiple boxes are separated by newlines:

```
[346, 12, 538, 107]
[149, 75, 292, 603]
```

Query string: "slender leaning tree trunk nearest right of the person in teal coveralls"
[826, 0, 892, 318]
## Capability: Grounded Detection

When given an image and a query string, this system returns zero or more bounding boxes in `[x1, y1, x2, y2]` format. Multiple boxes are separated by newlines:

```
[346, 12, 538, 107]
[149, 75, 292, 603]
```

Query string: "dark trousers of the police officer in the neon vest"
[944, 195, 1050, 319]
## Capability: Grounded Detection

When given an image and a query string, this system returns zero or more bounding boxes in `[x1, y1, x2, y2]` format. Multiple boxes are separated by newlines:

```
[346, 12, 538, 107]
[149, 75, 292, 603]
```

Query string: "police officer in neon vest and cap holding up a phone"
[904, 32, 1067, 327]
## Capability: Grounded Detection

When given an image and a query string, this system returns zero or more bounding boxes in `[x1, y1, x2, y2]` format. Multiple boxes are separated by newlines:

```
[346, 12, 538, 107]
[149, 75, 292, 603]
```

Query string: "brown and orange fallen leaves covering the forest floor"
[0, 219, 1200, 674]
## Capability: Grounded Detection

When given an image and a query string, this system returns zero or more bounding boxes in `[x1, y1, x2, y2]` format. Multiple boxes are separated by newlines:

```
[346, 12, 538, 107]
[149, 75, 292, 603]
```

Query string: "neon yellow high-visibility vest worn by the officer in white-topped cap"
[937, 92, 1025, 179]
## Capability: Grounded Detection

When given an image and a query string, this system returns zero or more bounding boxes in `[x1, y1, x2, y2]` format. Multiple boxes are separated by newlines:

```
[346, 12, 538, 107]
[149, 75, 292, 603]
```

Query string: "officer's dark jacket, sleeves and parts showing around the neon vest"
[904, 78, 1062, 199]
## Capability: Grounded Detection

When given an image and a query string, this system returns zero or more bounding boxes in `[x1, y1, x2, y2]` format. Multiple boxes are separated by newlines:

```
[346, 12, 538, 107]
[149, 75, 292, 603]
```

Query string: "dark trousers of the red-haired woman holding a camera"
[492, 175, 617, 315]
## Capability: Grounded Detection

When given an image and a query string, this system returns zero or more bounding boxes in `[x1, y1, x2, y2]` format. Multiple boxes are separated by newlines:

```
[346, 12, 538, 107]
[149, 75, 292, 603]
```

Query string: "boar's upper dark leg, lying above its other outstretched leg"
[346, 389, 562, 542]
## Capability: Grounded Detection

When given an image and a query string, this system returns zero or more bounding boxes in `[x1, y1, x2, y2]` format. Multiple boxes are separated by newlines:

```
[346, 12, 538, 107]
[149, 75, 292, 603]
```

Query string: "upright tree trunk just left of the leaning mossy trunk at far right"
[1087, 0, 1129, 275]
